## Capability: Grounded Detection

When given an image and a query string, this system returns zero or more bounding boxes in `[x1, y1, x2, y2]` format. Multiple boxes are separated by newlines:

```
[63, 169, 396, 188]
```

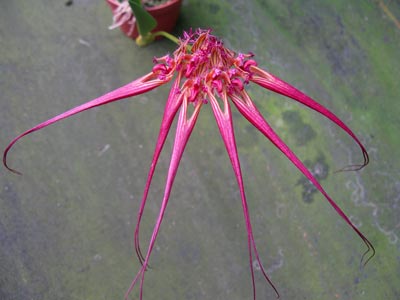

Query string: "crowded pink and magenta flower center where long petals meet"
[153, 30, 256, 102]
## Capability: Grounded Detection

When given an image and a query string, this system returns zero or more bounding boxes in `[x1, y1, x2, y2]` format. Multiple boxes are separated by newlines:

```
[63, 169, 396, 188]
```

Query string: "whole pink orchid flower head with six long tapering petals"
[3, 30, 375, 299]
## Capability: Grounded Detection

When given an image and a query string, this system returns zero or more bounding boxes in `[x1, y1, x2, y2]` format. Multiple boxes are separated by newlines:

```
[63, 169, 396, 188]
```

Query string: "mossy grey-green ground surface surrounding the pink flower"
[0, 0, 400, 300]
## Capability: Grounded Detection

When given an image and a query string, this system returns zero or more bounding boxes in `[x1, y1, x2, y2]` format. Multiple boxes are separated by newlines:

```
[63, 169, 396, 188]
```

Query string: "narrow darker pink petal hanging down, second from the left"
[135, 74, 183, 263]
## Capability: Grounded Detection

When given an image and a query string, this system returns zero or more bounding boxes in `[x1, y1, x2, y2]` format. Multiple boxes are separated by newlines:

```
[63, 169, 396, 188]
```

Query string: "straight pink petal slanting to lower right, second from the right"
[231, 91, 375, 265]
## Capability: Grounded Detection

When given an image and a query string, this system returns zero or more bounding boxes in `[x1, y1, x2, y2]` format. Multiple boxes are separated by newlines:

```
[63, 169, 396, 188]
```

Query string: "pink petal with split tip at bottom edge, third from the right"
[208, 90, 279, 300]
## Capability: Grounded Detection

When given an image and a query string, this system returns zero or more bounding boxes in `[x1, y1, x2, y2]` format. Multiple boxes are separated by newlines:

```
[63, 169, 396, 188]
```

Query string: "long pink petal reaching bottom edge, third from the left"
[125, 91, 202, 300]
